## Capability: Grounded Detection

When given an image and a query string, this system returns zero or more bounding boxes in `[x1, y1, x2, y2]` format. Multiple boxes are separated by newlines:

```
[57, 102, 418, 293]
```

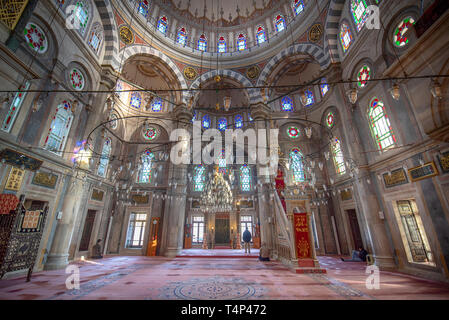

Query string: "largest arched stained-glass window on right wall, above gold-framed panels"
[368, 98, 396, 151]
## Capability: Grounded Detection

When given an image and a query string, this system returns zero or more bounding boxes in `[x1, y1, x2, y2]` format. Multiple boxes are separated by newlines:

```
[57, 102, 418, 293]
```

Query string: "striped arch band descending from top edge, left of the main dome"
[93, 0, 120, 70]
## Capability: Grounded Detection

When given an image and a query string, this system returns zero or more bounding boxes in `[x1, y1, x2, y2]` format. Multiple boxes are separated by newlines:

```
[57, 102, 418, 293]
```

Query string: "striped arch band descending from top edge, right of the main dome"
[324, 0, 345, 63]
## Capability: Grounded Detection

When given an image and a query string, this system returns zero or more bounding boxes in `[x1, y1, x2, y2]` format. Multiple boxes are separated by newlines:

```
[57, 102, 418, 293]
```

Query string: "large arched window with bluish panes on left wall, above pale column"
[44, 101, 73, 155]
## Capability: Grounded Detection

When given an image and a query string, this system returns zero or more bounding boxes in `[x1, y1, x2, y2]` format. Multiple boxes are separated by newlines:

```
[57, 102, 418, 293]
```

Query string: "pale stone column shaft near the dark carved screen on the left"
[45, 172, 84, 270]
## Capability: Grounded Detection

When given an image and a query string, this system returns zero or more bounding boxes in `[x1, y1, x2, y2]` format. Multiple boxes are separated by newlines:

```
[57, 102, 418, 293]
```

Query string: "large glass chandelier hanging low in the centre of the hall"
[200, 167, 234, 212]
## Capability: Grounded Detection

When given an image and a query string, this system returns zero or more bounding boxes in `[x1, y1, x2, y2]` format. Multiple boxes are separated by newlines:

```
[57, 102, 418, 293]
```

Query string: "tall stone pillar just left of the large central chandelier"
[163, 105, 193, 258]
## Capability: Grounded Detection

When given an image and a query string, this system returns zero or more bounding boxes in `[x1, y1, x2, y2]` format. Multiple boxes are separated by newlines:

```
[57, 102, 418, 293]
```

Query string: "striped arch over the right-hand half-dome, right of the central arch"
[257, 43, 330, 86]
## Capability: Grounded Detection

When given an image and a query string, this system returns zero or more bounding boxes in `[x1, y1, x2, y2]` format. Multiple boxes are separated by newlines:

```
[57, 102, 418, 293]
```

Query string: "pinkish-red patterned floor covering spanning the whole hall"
[0, 250, 449, 300]
